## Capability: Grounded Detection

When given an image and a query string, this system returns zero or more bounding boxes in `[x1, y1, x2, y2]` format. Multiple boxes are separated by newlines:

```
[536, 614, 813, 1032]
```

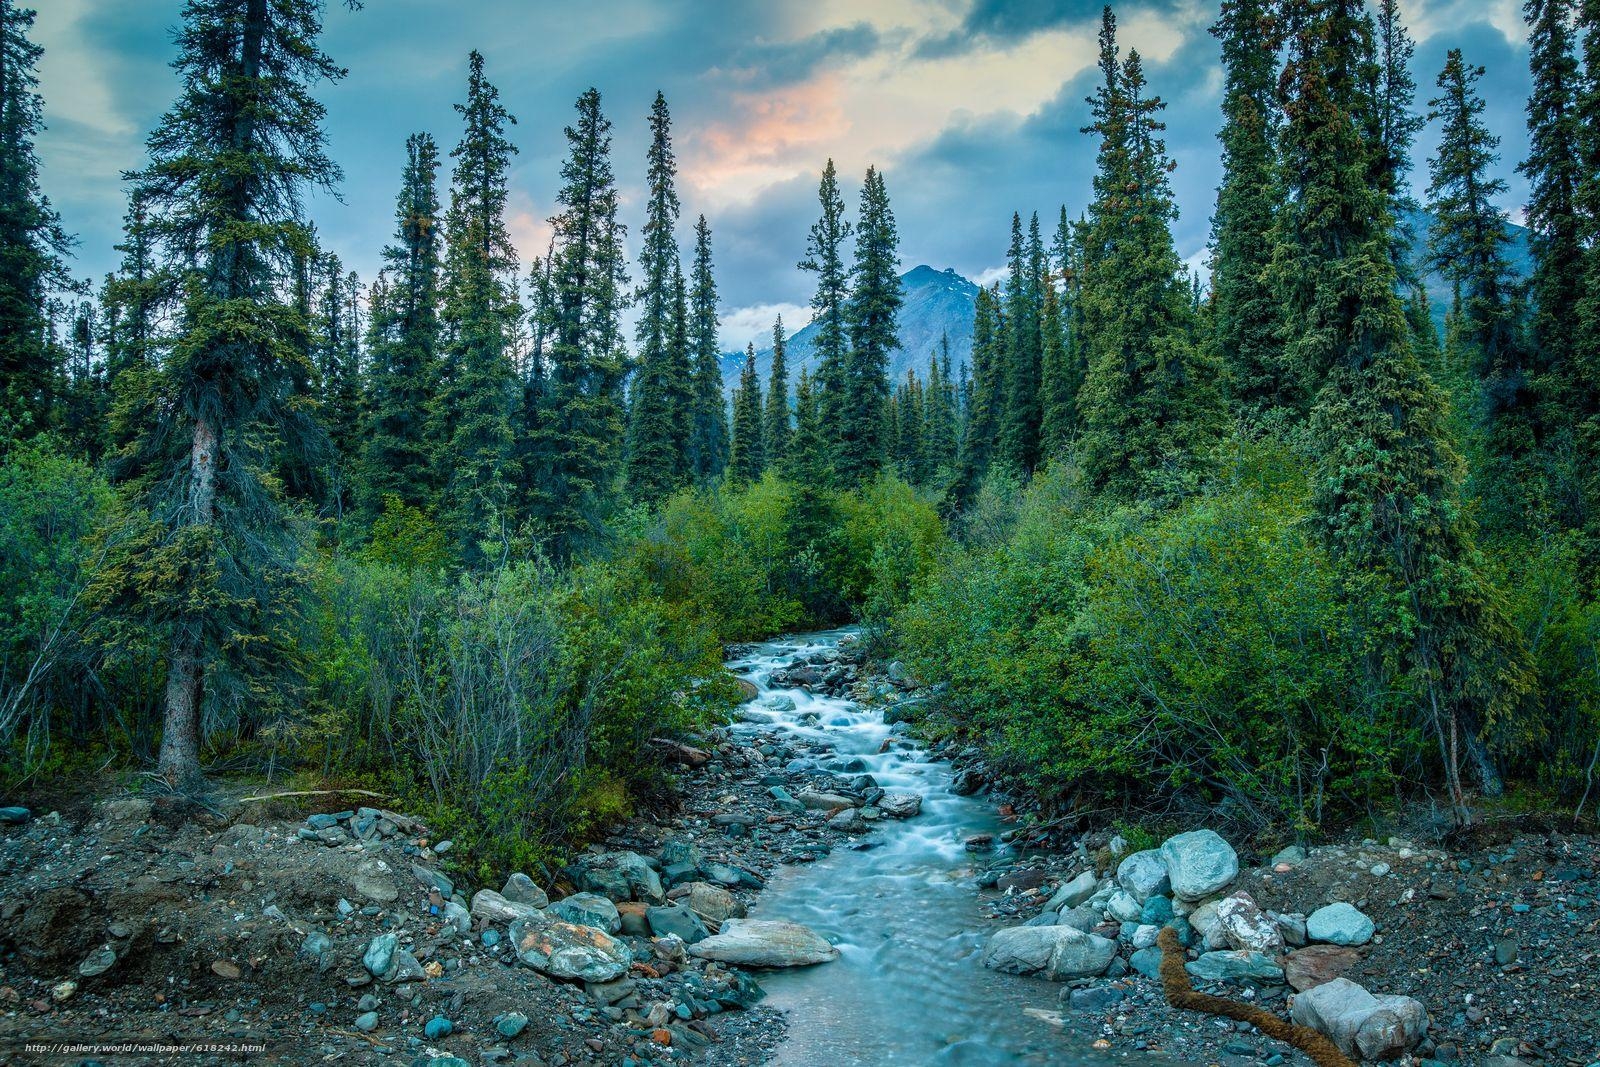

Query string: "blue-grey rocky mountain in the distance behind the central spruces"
[722, 266, 978, 396]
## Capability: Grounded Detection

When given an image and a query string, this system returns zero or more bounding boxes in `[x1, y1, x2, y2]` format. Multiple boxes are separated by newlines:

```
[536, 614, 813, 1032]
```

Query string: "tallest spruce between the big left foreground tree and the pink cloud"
[434, 51, 522, 565]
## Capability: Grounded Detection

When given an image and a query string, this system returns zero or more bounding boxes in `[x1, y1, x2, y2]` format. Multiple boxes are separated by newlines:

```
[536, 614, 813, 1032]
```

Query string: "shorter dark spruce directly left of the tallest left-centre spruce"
[358, 133, 443, 515]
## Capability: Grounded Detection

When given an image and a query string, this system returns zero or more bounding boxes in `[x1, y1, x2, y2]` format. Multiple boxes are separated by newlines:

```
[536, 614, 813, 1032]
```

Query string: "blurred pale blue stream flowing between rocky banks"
[728, 630, 1104, 1067]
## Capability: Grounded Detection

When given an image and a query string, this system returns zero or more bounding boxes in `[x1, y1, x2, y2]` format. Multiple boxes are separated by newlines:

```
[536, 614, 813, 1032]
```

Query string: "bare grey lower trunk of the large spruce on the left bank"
[157, 419, 218, 790]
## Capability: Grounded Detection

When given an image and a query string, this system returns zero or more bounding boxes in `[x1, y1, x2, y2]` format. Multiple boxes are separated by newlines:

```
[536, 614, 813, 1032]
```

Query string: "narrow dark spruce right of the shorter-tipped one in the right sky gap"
[1517, 0, 1584, 435]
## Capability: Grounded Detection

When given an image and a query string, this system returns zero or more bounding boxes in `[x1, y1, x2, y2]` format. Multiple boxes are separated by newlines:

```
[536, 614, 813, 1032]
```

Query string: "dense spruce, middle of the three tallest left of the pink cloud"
[533, 88, 627, 558]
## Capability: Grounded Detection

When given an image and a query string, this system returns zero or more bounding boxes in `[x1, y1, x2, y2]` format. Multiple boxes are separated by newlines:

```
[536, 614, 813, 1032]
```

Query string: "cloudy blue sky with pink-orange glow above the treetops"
[34, 0, 1530, 349]
